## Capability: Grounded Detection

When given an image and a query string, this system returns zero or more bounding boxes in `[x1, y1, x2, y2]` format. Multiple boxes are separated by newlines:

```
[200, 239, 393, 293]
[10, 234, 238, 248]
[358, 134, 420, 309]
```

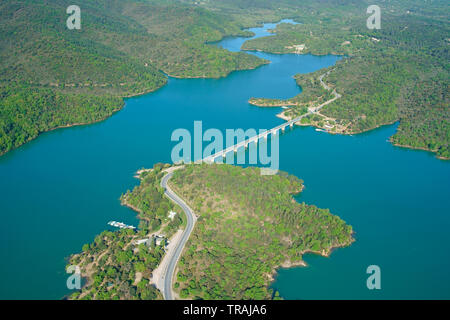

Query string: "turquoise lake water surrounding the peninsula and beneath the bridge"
[0, 20, 450, 299]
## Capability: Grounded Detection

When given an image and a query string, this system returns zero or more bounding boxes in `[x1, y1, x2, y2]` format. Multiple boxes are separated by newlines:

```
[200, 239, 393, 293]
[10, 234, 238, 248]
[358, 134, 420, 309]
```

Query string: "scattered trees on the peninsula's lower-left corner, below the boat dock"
[69, 229, 164, 300]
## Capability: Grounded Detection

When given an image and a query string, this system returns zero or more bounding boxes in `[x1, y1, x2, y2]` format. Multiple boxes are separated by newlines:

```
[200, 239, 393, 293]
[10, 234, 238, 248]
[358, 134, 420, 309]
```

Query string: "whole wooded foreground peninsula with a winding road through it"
[70, 164, 354, 299]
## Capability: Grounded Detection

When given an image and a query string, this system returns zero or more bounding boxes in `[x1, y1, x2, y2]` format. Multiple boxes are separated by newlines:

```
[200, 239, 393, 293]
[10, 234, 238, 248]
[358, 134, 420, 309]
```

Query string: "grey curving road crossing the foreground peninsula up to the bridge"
[161, 168, 197, 300]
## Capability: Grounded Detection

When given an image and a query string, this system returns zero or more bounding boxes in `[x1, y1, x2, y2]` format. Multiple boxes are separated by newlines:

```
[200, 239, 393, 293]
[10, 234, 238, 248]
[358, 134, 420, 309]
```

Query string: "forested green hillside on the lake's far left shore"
[0, 0, 266, 155]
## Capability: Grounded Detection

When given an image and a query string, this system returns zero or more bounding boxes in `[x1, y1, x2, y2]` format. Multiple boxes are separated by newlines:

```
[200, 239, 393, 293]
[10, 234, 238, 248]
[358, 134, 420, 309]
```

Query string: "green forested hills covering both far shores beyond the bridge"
[4, 0, 450, 158]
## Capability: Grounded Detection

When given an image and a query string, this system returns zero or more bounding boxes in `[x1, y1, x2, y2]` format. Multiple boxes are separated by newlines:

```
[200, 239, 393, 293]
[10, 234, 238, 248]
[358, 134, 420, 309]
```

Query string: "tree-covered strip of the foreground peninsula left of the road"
[69, 164, 185, 300]
